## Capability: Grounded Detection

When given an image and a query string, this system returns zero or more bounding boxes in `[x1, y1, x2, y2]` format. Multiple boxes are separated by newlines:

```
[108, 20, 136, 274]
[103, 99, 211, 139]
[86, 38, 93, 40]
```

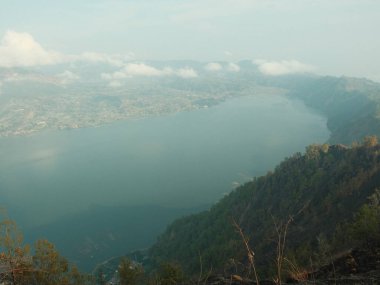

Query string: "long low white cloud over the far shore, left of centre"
[101, 63, 198, 81]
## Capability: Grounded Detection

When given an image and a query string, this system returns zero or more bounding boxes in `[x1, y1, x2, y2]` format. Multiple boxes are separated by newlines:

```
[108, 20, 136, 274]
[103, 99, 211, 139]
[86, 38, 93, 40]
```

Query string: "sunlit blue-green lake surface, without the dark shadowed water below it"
[0, 95, 329, 224]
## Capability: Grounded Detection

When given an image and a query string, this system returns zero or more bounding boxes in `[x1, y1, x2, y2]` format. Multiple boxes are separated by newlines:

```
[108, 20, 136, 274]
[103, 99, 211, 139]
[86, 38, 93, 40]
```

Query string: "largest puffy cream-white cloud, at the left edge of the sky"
[0, 31, 65, 67]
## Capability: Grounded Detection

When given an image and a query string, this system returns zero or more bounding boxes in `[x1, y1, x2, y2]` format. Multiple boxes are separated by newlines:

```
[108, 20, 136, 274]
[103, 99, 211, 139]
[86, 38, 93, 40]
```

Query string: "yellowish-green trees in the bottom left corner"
[0, 213, 92, 285]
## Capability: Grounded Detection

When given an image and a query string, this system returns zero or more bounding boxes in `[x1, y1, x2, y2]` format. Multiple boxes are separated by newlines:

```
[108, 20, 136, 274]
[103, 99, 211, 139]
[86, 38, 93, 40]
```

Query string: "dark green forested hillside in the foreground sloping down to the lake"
[147, 137, 380, 276]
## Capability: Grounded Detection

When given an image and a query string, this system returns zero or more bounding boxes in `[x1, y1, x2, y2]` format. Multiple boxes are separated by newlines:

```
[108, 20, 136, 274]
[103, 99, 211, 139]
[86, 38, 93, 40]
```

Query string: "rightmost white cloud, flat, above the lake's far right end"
[254, 60, 315, 76]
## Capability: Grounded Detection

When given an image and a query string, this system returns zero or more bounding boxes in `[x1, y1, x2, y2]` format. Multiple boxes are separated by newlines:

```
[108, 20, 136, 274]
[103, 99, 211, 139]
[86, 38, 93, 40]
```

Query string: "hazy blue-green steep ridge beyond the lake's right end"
[277, 76, 380, 144]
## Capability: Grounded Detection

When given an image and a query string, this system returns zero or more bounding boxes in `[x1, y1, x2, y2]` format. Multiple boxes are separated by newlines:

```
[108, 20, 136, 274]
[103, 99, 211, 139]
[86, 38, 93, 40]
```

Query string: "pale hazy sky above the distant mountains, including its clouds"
[0, 0, 380, 82]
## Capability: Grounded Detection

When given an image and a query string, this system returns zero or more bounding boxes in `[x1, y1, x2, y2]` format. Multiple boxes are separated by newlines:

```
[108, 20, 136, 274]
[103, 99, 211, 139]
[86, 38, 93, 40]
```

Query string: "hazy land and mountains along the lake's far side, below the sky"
[0, 60, 380, 143]
